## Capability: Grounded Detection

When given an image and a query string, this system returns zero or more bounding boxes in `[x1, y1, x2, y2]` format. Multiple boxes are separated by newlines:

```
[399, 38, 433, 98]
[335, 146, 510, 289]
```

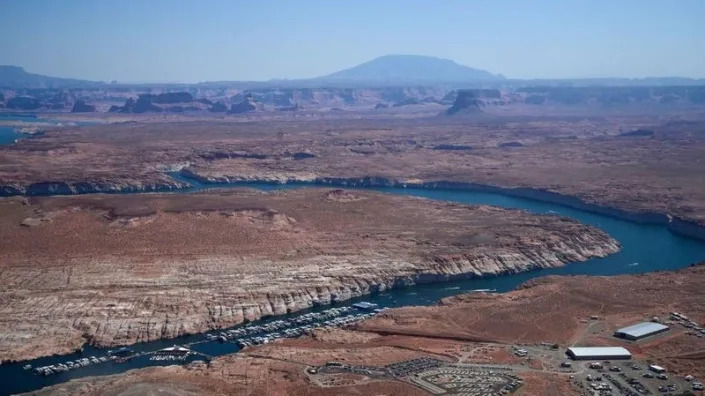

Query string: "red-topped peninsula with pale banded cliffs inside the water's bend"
[0, 188, 619, 360]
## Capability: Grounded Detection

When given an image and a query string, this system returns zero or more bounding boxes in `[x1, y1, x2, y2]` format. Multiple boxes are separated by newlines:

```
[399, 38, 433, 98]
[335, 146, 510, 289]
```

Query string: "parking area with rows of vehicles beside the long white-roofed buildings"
[309, 343, 702, 396]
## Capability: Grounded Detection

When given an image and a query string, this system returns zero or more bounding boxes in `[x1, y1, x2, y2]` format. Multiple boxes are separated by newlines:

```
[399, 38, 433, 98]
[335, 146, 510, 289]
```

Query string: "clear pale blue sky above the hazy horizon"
[0, 0, 705, 82]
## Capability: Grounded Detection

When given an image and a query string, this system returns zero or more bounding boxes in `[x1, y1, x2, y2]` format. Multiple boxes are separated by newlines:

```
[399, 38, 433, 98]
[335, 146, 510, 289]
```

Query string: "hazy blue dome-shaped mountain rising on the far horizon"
[316, 55, 504, 84]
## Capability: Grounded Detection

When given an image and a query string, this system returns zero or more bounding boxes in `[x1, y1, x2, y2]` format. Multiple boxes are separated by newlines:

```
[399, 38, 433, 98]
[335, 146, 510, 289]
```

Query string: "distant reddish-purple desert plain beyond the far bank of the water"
[0, 107, 705, 232]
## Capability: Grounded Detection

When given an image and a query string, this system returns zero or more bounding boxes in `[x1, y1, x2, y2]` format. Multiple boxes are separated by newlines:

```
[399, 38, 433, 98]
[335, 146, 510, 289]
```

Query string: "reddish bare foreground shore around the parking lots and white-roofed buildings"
[30, 265, 705, 395]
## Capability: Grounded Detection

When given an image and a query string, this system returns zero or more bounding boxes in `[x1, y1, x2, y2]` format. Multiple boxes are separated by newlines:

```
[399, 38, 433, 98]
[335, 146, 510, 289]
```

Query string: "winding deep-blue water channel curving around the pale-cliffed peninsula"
[0, 166, 705, 394]
